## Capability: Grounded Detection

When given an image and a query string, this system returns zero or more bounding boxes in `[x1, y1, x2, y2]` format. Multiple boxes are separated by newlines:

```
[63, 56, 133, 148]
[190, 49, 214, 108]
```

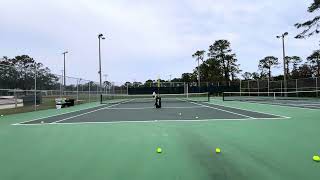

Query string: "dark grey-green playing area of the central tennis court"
[16, 96, 286, 125]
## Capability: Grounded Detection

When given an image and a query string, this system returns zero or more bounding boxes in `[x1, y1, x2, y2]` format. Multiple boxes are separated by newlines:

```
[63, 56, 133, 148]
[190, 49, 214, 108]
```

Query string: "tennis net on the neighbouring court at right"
[223, 90, 320, 101]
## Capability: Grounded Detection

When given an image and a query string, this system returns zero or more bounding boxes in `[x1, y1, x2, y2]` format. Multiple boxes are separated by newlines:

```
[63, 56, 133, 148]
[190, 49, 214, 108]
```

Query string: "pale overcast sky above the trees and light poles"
[0, 0, 319, 82]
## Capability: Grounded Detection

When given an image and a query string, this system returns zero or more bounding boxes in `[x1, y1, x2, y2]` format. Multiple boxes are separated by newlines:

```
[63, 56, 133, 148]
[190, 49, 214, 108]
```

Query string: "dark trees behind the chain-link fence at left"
[0, 55, 99, 91]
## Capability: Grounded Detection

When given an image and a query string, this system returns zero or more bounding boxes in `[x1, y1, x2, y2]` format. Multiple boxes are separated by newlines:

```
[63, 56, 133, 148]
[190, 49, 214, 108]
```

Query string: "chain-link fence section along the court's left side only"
[0, 64, 104, 114]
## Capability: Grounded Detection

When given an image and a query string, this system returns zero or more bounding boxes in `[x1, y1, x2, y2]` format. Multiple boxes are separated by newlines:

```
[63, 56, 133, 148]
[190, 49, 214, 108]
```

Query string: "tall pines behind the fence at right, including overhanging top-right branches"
[173, 0, 320, 83]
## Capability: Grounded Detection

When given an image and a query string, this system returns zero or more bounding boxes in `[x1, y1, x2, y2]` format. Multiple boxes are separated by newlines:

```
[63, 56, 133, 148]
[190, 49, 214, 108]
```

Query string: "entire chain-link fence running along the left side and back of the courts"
[0, 64, 320, 114]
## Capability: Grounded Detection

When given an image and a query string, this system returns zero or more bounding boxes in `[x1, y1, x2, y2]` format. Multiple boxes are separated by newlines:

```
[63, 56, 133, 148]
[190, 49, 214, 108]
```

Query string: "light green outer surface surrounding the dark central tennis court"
[0, 99, 320, 180]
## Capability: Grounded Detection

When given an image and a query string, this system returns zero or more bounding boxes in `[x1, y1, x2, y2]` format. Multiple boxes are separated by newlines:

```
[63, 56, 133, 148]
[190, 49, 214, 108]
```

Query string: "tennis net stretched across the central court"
[101, 93, 210, 104]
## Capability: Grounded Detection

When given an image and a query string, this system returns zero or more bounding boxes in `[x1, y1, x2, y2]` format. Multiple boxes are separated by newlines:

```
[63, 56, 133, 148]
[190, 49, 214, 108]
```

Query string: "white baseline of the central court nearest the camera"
[12, 118, 286, 126]
